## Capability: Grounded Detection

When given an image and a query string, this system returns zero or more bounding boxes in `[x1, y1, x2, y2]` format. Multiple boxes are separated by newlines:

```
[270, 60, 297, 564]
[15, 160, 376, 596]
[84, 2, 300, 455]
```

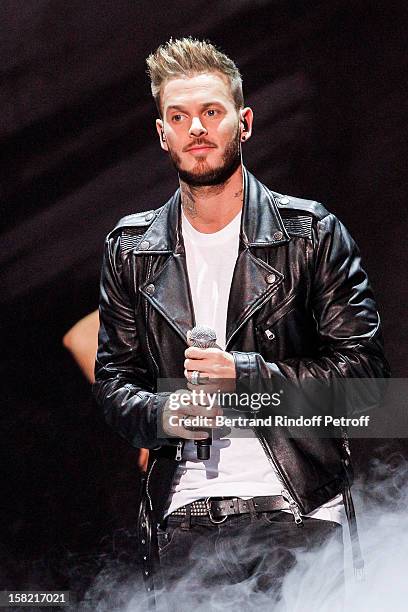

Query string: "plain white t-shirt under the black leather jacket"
[166, 208, 343, 522]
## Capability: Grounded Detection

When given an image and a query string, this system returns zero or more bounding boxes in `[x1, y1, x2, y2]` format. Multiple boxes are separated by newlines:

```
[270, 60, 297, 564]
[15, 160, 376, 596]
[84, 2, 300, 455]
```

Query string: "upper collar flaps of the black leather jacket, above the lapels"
[136, 167, 289, 255]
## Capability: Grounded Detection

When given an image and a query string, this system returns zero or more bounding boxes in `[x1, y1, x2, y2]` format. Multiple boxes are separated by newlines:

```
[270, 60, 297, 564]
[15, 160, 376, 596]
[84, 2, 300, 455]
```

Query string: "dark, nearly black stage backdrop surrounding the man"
[0, 0, 408, 600]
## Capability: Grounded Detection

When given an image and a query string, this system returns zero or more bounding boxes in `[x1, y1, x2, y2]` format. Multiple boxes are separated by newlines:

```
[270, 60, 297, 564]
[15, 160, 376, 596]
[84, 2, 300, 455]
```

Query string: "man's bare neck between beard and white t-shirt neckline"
[180, 165, 244, 234]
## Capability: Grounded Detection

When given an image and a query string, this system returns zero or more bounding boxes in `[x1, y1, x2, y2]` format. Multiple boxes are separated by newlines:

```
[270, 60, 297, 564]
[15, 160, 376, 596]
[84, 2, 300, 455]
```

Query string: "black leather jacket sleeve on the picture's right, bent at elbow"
[233, 214, 390, 394]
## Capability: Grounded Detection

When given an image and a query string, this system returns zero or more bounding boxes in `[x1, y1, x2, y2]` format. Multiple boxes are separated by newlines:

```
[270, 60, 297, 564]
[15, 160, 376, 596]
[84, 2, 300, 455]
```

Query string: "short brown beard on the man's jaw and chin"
[169, 126, 241, 187]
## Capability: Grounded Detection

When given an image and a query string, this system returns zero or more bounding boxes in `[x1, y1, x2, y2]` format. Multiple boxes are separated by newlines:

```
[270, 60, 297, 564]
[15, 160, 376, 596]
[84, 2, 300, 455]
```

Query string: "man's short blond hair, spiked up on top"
[146, 36, 244, 115]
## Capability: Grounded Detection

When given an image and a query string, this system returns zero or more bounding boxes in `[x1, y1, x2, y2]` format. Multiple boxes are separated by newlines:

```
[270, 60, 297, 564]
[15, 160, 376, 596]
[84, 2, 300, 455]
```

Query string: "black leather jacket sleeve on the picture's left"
[93, 232, 169, 448]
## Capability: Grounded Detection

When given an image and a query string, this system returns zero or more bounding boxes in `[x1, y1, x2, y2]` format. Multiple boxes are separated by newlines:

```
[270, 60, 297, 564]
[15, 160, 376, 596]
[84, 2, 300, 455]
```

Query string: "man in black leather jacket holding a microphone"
[95, 38, 388, 608]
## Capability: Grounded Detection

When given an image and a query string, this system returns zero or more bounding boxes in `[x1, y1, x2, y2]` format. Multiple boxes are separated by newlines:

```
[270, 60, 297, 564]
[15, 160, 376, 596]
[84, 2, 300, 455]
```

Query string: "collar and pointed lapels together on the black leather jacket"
[139, 169, 289, 350]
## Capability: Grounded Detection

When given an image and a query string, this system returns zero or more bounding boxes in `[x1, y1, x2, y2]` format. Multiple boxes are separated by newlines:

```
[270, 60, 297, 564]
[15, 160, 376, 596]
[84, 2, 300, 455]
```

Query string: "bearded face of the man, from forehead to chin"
[156, 72, 245, 187]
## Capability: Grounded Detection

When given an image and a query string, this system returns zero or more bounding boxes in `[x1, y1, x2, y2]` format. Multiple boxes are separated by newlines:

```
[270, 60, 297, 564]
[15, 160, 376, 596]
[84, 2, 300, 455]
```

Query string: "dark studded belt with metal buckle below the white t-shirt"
[170, 495, 289, 522]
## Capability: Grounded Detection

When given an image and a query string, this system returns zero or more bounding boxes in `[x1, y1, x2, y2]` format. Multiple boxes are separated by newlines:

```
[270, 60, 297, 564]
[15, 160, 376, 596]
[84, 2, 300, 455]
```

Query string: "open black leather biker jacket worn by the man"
[94, 169, 389, 522]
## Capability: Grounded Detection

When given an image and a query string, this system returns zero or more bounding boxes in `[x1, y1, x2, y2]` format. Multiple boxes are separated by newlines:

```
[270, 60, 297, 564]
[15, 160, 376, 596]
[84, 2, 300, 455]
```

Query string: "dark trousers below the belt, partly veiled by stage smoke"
[156, 512, 344, 612]
